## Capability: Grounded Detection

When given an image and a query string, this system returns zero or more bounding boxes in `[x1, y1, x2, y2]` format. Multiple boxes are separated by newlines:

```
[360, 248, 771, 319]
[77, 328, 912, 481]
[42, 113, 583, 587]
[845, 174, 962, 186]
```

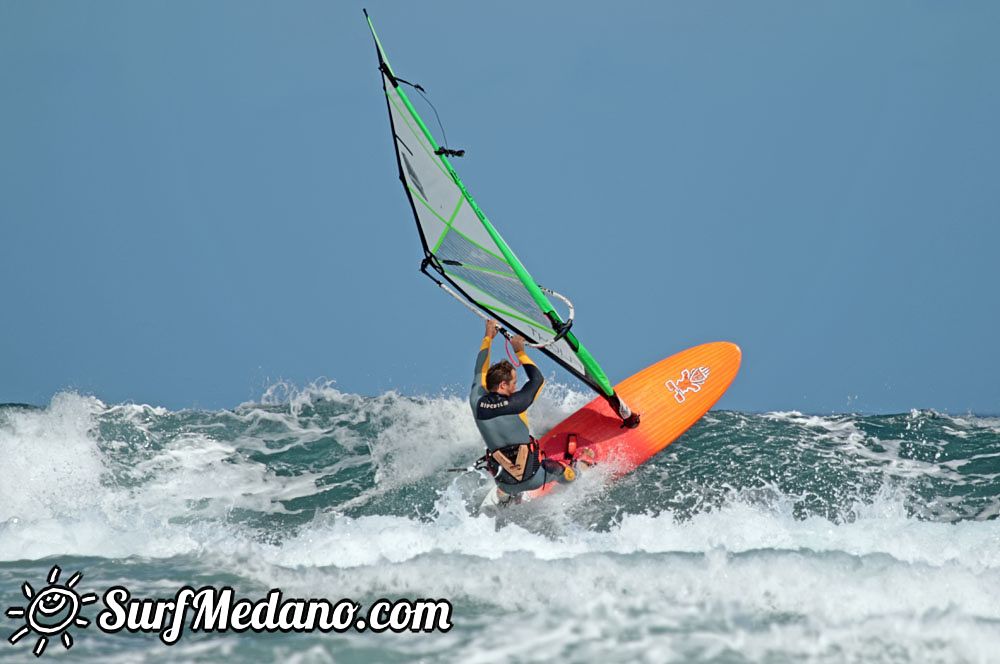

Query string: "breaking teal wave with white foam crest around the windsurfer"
[0, 392, 1000, 569]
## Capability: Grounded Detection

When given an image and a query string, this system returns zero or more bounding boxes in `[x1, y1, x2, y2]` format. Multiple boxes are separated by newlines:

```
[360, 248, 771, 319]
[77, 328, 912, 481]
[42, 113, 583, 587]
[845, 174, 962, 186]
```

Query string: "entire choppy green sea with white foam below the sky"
[0, 385, 1000, 662]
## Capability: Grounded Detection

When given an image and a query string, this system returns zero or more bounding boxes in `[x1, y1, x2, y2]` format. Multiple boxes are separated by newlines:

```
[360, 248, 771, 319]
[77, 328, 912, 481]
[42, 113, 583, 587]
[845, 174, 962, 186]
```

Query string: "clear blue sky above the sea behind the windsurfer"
[0, 0, 1000, 413]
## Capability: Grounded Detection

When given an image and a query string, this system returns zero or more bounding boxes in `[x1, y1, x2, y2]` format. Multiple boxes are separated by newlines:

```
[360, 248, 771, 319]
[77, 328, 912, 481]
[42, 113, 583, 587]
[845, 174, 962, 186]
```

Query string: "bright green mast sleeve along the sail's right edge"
[366, 13, 614, 397]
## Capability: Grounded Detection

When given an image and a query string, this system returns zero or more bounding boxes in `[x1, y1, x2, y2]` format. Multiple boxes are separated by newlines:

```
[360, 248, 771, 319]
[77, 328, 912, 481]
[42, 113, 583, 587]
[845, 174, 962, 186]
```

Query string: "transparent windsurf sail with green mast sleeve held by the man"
[365, 11, 637, 425]
